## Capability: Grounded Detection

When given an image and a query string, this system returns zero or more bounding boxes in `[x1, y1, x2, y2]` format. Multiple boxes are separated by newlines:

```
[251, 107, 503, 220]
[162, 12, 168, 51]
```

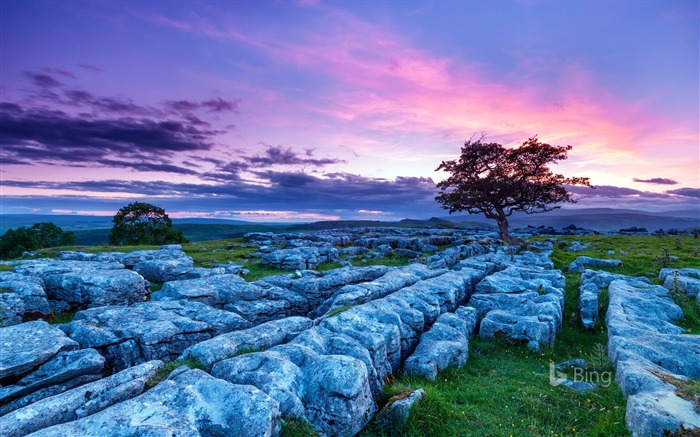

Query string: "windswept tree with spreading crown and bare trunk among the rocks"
[435, 137, 591, 246]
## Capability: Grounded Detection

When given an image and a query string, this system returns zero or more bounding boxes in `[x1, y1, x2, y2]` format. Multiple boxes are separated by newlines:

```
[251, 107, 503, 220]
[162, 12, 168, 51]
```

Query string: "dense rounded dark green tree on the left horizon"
[109, 202, 187, 246]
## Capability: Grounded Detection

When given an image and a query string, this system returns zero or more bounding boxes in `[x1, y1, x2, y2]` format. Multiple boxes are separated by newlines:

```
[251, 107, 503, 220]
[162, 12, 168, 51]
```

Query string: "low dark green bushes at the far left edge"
[0, 222, 75, 258]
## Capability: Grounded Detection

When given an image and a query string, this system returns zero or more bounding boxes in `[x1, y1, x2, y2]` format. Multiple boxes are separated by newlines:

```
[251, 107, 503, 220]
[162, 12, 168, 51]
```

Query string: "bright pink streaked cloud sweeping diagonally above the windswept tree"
[148, 5, 700, 184]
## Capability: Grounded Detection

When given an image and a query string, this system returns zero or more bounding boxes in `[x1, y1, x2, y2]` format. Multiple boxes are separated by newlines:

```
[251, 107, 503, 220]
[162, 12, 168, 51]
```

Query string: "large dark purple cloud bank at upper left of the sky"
[0, 70, 243, 175]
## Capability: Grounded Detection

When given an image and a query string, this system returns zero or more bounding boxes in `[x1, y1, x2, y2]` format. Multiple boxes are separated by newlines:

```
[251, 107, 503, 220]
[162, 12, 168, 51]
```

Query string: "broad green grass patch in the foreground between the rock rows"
[361, 339, 628, 436]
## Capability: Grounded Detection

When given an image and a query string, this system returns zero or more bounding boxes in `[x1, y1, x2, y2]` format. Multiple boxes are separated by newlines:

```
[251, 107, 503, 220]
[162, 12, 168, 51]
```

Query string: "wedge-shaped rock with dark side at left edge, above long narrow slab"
[0, 349, 105, 403]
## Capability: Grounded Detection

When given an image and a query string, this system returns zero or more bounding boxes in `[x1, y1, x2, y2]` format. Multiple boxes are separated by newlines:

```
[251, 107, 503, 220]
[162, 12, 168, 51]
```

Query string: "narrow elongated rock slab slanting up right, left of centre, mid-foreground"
[182, 317, 313, 369]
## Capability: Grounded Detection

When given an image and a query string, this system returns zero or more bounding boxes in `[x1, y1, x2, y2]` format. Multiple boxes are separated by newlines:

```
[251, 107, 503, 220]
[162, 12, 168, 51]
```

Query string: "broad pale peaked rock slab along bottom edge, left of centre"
[26, 370, 280, 437]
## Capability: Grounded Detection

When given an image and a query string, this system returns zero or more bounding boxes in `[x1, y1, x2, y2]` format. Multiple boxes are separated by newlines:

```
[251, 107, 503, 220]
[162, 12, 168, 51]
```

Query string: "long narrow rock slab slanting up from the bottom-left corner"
[0, 361, 163, 437]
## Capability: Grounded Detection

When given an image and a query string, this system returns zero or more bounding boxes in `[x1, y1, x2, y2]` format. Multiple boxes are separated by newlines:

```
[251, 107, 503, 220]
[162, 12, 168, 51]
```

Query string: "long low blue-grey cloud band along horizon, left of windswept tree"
[3, 172, 439, 217]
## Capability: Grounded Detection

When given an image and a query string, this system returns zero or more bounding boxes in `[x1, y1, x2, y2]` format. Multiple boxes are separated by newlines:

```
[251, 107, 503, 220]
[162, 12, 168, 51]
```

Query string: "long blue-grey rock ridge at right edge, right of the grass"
[606, 279, 700, 436]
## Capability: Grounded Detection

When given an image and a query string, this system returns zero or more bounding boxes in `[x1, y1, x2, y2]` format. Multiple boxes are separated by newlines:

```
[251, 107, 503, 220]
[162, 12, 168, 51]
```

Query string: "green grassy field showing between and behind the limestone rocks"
[5, 236, 700, 437]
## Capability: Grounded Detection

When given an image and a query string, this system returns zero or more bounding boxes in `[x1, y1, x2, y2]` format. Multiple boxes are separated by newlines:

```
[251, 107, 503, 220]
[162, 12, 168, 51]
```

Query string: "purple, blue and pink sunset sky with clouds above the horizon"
[0, 0, 700, 222]
